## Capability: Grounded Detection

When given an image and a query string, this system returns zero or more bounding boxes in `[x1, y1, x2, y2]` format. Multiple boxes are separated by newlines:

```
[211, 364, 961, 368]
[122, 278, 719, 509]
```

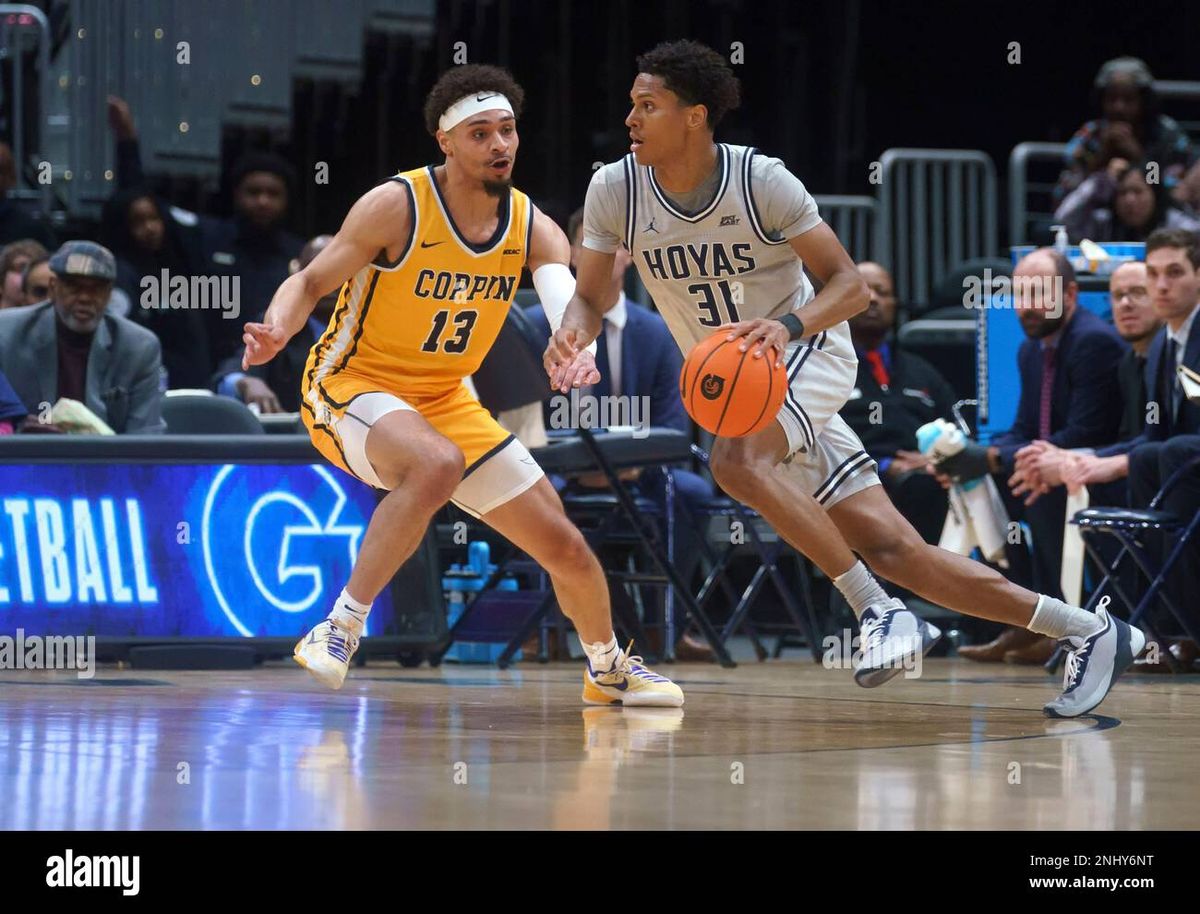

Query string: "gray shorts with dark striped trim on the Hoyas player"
[776, 333, 880, 509]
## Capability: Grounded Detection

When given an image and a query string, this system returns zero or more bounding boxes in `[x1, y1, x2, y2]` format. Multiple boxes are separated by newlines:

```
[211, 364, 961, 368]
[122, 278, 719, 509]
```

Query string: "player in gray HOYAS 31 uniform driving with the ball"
[545, 41, 1145, 717]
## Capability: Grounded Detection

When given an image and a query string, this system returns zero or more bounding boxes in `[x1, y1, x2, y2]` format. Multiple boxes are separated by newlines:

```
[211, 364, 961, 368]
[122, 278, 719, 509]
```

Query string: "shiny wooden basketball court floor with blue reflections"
[0, 660, 1200, 830]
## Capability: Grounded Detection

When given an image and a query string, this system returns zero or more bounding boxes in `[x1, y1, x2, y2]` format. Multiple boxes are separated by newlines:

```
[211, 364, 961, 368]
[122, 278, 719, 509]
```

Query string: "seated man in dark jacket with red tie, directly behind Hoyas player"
[841, 261, 956, 545]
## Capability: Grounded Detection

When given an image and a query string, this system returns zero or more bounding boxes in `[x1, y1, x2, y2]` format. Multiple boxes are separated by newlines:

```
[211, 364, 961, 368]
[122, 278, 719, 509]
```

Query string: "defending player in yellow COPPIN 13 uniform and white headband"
[244, 65, 683, 706]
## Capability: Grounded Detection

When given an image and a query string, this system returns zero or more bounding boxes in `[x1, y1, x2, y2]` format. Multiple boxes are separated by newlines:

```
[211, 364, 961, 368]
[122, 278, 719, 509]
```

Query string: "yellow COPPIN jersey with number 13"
[304, 166, 533, 399]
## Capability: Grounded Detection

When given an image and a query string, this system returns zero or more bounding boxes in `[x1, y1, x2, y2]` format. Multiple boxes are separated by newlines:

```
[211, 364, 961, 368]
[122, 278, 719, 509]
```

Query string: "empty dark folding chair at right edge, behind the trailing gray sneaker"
[1045, 455, 1200, 673]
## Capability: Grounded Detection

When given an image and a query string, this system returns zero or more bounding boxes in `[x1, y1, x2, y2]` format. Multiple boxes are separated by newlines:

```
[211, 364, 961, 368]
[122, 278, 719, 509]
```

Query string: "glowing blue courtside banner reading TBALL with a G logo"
[0, 463, 392, 637]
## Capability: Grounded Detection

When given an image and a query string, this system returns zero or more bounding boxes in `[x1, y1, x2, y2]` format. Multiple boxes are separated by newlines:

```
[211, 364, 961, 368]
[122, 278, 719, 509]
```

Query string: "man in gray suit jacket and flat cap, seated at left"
[0, 241, 166, 434]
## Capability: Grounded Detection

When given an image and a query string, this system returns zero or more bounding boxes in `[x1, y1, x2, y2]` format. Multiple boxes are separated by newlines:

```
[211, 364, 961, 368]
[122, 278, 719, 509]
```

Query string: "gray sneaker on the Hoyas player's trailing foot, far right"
[1043, 597, 1146, 717]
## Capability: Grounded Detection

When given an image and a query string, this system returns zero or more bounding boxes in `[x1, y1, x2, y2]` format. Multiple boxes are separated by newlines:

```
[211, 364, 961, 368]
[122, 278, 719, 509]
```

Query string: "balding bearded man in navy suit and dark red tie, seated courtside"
[940, 248, 1126, 660]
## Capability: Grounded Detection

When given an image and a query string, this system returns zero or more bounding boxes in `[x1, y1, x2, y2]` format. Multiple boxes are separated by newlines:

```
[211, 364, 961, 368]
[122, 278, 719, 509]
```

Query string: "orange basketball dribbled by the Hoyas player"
[679, 331, 787, 438]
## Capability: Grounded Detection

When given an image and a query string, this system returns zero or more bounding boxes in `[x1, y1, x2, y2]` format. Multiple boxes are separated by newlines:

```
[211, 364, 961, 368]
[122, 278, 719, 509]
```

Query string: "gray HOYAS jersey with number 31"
[583, 143, 857, 363]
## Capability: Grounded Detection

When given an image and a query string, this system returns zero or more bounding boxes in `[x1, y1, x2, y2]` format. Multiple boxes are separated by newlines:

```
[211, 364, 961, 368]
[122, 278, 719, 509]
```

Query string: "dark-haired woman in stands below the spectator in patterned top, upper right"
[1054, 158, 1200, 245]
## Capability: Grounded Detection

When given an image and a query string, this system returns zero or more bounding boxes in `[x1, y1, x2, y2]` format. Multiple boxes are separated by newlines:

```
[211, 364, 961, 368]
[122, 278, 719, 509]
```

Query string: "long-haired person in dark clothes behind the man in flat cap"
[102, 187, 215, 387]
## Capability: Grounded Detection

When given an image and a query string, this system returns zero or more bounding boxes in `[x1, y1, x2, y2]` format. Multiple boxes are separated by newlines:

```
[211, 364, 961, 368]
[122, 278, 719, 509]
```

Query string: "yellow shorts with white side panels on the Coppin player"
[300, 372, 544, 517]
